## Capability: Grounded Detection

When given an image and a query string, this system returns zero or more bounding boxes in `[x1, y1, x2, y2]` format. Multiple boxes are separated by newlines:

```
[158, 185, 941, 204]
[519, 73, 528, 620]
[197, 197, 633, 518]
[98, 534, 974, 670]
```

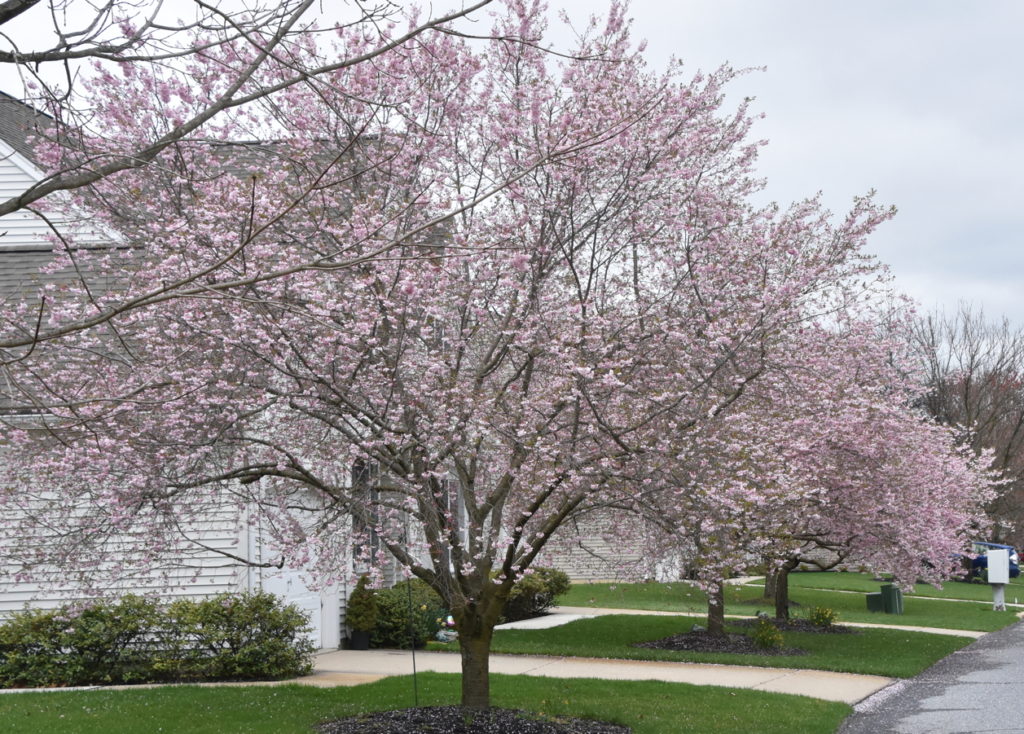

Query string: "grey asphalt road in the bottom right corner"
[839, 622, 1024, 734]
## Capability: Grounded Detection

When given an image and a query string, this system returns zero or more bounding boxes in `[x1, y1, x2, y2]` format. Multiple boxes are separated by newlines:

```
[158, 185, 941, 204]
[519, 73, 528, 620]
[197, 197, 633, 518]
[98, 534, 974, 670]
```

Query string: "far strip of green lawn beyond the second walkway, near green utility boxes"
[558, 573, 1024, 632]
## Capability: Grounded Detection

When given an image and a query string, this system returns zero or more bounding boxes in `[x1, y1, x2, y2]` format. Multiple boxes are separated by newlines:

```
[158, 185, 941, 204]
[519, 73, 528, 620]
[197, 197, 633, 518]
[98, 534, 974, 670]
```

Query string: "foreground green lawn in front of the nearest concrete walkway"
[0, 674, 851, 734]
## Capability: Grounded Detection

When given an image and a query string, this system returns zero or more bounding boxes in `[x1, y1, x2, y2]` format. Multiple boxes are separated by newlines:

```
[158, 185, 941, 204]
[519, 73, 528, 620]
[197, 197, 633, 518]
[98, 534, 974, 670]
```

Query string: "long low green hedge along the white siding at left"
[0, 593, 314, 688]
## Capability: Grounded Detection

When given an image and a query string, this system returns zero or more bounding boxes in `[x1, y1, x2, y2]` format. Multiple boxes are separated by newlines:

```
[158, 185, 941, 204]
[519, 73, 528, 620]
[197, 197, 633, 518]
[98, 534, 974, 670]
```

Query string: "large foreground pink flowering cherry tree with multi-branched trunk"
[0, 0, 950, 707]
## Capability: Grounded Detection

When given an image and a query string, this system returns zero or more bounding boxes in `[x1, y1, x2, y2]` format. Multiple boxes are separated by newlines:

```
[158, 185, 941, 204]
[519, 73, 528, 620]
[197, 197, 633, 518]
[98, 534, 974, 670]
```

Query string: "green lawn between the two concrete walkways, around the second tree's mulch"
[492, 614, 971, 678]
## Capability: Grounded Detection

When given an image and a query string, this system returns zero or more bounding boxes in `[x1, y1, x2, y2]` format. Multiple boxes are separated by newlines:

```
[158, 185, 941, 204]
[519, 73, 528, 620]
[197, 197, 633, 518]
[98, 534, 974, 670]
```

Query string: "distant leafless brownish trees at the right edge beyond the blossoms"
[913, 305, 1024, 545]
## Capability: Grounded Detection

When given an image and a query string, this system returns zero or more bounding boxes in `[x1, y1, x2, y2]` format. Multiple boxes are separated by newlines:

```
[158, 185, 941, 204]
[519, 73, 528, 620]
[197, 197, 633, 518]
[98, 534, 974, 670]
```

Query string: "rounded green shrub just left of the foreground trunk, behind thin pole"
[370, 578, 447, 649]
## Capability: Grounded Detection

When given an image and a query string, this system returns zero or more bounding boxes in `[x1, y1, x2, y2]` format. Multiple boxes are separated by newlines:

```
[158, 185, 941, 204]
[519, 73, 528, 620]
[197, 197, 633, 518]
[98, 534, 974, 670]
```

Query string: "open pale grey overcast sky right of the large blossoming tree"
[551, 0, 1024, 327]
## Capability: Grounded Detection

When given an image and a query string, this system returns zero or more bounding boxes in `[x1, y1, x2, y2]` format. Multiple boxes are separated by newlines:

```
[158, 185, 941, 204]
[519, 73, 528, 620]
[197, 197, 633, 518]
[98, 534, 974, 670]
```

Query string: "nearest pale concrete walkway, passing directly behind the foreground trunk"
[294, 650, 893, 703]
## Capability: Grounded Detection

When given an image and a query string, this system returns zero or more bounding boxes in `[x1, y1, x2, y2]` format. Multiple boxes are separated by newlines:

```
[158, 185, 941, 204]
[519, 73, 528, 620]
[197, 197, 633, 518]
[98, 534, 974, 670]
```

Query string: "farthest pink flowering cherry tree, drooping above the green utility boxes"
[761, 314, 998, 618]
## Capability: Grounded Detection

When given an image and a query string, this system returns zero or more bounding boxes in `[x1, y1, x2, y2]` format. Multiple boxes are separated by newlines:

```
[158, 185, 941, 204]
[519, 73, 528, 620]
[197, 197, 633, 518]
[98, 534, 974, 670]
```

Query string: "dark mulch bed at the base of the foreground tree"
[317, 706, 633, 734]
